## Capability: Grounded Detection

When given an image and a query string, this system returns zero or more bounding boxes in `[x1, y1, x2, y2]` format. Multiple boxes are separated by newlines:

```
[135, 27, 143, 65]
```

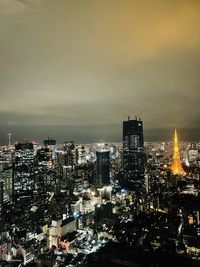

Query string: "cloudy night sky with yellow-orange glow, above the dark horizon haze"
[0, 0, 200, 142]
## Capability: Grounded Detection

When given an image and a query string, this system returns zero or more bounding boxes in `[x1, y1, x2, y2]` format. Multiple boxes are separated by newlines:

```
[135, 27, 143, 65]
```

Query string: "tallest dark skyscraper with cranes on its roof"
[123, 118, 145, 189]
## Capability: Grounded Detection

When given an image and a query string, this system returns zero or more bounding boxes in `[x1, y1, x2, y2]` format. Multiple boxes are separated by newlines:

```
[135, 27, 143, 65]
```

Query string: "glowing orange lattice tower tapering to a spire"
[171, 129, 186, 175]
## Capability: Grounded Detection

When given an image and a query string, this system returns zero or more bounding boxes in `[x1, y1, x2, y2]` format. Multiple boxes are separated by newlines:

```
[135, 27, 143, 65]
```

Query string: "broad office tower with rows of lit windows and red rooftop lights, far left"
[14, 143, 35, 195]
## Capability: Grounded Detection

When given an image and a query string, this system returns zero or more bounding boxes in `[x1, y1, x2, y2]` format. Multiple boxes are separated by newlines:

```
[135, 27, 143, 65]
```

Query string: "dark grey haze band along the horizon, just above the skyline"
[0, 123, 200, 145]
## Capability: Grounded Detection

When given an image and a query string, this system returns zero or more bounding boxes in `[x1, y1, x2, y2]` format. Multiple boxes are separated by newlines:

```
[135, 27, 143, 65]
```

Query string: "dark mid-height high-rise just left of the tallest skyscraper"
[95, 150, 110, 187]
